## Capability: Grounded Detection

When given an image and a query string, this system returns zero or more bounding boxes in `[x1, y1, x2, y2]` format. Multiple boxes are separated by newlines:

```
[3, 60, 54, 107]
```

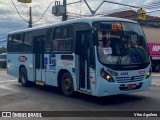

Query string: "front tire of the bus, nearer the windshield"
[61, 72, 74, 97]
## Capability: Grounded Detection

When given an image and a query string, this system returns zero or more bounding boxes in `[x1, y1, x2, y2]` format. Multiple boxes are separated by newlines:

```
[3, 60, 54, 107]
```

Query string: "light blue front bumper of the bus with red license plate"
[95, 77, 151, 97]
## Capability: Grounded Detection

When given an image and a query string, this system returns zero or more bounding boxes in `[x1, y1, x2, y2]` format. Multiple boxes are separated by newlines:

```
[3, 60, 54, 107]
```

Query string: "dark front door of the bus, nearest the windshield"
[76, 31, 90, 92]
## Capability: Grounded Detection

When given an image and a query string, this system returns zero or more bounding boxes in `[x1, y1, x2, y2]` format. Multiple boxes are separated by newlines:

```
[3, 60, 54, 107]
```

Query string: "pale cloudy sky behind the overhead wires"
[0, 0, 160, 47]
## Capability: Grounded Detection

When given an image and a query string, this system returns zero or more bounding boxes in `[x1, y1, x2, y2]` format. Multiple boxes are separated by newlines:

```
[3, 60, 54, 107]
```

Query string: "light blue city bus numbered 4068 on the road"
[7, 17, 151, 96]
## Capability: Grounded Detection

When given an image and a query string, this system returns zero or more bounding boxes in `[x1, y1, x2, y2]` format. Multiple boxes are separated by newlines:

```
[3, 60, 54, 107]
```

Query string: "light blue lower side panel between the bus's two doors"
[44, 54, 77, 90]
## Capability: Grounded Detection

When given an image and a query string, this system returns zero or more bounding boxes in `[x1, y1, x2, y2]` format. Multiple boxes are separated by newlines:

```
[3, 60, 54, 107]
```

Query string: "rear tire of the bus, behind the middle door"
[19, 67, 29, 87]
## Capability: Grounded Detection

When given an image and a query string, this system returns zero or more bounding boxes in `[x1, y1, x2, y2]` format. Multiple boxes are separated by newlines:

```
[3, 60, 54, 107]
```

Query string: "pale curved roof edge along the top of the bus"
[9, 17, 137, 34]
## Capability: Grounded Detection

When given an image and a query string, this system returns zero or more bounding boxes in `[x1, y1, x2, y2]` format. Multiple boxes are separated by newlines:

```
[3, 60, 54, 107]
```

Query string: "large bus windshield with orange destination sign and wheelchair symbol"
[97, 22, 149, 65]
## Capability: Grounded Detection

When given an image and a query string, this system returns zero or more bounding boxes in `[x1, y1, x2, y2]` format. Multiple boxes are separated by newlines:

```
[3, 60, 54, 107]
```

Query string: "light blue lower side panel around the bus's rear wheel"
[7, 54, 34, 81]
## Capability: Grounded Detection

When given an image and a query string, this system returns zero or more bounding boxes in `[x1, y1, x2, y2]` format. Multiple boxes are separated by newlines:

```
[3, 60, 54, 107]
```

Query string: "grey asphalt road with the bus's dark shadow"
[0, 70, 160, 120]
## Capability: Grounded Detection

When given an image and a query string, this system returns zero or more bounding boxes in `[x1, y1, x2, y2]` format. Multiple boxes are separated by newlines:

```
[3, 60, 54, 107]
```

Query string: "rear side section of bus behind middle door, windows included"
[7, 32, 34, 80]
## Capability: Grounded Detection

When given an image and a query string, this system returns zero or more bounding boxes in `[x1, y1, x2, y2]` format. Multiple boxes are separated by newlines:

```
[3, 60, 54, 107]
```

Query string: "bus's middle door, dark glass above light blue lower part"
[34, 36, 45, 82]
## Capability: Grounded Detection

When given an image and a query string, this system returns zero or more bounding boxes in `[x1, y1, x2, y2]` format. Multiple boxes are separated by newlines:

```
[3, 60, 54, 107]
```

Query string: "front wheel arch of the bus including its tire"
[57, 69, 74, 96]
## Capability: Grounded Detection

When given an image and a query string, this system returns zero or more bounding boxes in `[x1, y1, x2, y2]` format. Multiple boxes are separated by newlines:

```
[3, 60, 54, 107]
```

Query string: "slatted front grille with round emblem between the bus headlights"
[116, 75, 144, 83]
